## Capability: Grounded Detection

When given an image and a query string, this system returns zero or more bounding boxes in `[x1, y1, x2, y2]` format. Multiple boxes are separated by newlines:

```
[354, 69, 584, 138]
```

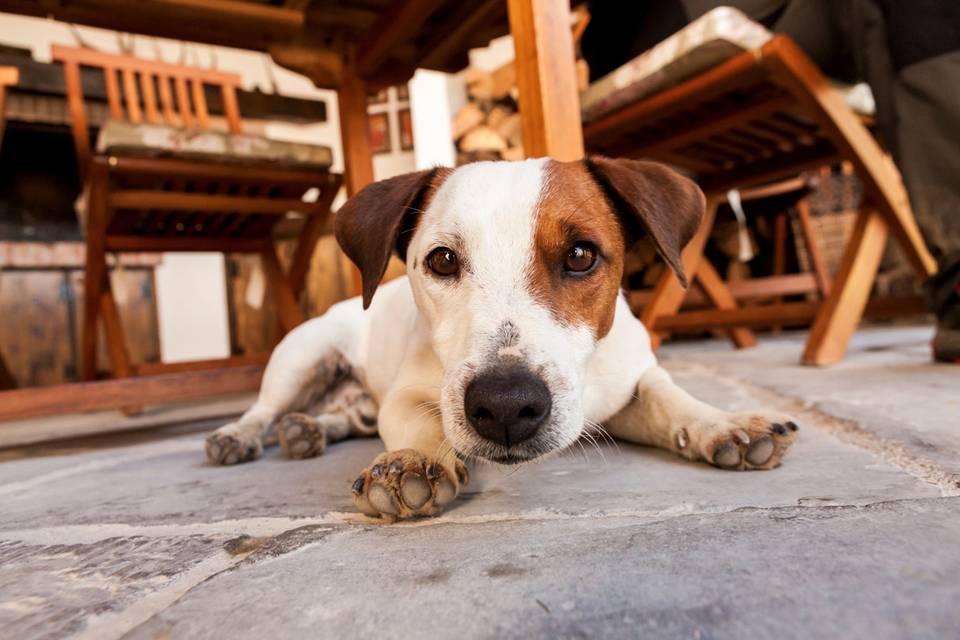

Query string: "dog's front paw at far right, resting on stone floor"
[675, 413, 799, 471]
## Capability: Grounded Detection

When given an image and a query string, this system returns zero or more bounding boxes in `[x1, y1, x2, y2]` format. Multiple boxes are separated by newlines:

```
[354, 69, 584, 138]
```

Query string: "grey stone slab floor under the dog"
[0, 328, 960, 640]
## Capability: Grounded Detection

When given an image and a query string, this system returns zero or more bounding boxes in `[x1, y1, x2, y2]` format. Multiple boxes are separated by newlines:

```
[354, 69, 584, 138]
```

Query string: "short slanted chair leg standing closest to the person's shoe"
[803, 207, 890, 366]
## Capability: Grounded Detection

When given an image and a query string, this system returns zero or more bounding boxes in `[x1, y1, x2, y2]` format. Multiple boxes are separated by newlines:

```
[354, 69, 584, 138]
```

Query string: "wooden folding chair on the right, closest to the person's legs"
[584, 35, 936, 365]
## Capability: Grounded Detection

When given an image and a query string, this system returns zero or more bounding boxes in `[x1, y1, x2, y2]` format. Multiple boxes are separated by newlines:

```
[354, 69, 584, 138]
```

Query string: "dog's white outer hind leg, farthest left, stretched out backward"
[206, 318, 351, 464]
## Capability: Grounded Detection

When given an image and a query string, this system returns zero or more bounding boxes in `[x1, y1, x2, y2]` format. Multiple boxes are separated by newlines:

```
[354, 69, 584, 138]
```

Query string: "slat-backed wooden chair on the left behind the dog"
[53, 46, 340, 380]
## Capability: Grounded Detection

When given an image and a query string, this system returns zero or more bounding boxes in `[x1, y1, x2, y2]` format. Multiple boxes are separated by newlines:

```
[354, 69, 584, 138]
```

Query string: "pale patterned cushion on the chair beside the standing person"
[580, 7, 873, 122]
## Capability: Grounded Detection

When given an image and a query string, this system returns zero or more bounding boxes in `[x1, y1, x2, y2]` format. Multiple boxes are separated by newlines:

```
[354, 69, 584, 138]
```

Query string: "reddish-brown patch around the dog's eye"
[529, 162, 624, 340]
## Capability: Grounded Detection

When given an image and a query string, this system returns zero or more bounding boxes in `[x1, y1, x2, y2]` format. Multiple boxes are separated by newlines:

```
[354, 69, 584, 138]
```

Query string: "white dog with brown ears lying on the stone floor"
[206, 157, 797, 521]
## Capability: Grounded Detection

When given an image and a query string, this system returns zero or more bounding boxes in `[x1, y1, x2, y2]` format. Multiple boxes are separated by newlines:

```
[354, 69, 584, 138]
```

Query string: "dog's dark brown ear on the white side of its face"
[335, 169, 440, 309]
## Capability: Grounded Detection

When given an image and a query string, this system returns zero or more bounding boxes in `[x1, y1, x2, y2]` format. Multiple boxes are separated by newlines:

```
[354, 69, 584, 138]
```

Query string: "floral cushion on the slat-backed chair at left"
[97, 120, 333, 169]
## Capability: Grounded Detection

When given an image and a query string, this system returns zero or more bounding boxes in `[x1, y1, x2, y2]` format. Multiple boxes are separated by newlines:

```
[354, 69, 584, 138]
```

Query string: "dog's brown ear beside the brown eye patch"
[586, 156, 705, 287]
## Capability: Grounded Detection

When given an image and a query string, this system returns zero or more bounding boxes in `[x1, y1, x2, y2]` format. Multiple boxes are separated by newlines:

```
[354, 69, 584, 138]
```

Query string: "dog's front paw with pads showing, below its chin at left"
[352, 449, 469, 521]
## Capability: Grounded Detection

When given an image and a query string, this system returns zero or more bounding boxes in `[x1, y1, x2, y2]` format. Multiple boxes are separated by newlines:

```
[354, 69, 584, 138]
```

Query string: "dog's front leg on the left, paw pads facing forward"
[353, 392, 469, 521]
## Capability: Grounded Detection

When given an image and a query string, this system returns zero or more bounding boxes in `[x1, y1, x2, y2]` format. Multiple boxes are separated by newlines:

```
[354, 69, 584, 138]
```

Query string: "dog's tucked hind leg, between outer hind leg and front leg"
[277, 375, 377, 459]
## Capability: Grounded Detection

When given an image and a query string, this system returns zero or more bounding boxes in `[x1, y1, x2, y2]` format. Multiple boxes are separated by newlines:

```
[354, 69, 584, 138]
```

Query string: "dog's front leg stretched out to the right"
[606, 366, 797, 470]
